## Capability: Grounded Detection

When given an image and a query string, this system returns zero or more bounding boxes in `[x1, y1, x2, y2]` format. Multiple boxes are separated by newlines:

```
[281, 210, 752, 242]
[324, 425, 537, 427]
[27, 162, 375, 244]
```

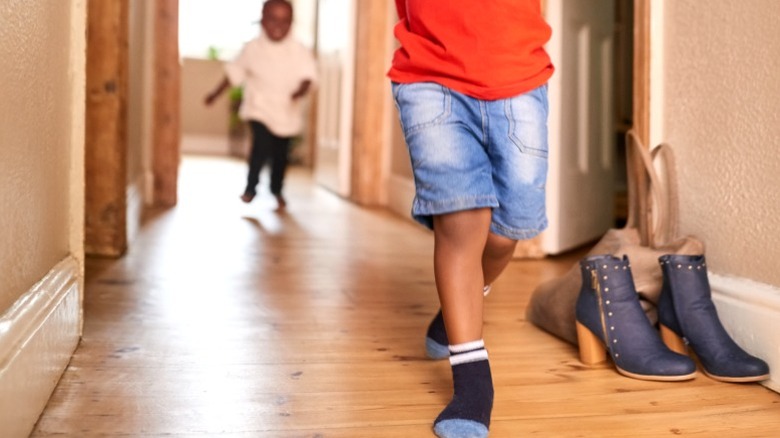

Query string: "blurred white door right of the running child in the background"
[314, 0, 355, 197]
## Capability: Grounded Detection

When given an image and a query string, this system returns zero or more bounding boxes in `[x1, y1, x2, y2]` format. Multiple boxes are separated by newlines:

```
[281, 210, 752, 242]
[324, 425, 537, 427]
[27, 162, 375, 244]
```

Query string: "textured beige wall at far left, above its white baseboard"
[0, 0, 84, 315]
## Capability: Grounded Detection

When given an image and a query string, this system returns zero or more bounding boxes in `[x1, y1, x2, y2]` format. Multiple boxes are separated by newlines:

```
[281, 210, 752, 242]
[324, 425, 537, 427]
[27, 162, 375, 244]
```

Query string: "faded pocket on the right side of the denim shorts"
[504, 85, 549, 158]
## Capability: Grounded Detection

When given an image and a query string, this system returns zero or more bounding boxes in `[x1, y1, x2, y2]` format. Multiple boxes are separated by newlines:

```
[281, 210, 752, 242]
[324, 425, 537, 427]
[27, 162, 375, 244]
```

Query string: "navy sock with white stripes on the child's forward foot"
[433, 340, 493, 438]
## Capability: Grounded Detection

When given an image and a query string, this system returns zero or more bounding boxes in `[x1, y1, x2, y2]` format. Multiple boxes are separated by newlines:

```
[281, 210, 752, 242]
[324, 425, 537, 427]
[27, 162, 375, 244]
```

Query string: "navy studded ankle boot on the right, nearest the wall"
[658, 255, 769, 382]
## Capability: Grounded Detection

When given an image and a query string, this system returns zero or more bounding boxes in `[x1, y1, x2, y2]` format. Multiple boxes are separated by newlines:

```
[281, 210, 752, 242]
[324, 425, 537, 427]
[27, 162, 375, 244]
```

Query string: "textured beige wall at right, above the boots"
[663, 0, 780, 286]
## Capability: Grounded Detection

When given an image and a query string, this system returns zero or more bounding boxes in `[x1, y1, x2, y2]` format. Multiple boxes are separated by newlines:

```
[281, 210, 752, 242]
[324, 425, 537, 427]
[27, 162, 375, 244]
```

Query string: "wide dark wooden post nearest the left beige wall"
[84, 0, 129, 256]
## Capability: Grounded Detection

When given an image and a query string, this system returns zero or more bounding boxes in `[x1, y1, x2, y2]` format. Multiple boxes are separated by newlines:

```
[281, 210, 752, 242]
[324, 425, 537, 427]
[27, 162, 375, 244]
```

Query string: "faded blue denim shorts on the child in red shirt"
[393, 82, 548, 240]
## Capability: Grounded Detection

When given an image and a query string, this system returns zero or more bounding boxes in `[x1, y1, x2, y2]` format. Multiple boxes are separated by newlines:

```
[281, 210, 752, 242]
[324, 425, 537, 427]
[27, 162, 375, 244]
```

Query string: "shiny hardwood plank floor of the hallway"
[32, 157, 780, 438]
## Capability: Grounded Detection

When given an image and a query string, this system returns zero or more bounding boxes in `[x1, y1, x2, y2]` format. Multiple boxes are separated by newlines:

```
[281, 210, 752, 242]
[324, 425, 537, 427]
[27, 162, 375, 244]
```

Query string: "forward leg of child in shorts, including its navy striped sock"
[433, 209, 493, 438]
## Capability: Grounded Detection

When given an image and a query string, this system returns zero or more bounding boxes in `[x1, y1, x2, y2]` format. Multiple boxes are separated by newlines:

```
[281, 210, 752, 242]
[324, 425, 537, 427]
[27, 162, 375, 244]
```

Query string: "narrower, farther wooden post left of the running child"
[152, 0, 181, 207]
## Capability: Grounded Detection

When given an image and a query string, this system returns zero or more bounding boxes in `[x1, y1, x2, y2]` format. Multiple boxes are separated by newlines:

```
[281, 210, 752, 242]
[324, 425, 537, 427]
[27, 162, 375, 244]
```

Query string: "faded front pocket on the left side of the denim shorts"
[393, 82, 452, 135]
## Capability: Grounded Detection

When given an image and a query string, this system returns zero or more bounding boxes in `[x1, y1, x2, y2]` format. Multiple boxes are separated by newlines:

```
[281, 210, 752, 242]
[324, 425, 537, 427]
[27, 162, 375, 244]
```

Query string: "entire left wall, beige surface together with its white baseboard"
[0, 0, 87, 437]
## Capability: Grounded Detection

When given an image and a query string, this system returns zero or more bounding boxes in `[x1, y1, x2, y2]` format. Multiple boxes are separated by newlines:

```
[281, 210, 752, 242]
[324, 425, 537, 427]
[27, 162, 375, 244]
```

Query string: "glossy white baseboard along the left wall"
[0, 257, 82, 438]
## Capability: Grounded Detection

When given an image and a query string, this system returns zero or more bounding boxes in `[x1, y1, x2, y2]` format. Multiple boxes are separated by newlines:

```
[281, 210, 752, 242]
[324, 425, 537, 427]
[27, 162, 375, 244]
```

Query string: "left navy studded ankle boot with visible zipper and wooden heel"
[576, 255, 696, 381]
